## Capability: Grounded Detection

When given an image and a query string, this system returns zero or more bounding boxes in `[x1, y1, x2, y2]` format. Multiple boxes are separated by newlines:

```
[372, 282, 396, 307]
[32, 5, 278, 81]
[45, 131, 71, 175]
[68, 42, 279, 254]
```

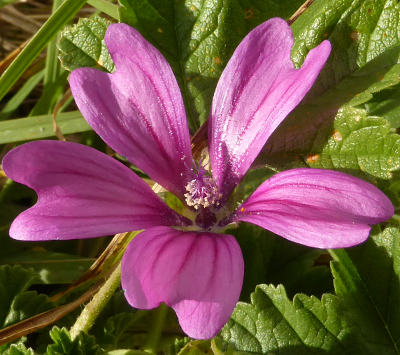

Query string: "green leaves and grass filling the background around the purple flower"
[0, 0, 400, 355]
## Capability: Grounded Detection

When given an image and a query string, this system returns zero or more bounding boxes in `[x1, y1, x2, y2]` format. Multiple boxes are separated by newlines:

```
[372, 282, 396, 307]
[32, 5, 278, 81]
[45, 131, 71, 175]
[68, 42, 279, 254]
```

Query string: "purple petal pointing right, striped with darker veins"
[234, 169, 394, 248]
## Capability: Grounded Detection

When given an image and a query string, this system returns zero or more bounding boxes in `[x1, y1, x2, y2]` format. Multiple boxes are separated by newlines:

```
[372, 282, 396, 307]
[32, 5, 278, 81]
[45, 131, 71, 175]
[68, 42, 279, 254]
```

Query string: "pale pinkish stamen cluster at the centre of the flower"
[185, 167, 221, 210]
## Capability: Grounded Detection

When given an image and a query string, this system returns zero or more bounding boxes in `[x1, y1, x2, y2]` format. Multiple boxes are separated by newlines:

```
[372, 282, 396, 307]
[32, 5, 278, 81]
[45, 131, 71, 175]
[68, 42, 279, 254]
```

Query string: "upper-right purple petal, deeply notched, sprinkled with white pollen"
[209, 18, 331, 198]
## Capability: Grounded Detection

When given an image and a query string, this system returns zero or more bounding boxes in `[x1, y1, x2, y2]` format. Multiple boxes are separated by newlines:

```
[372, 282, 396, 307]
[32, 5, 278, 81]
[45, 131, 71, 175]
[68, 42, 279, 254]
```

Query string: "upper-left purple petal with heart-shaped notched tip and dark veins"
[69, 24, 192, 197]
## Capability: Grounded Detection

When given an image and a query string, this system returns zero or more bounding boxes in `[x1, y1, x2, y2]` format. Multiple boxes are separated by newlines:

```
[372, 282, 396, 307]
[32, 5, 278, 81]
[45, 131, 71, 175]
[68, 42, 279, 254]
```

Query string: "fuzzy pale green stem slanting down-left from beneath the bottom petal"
[70, 263, 121, 339]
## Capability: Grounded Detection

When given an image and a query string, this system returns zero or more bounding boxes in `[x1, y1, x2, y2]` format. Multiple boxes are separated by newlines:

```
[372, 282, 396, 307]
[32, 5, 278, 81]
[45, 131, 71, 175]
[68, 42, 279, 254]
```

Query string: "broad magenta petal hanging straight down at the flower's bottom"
[121, 227, 243, 339]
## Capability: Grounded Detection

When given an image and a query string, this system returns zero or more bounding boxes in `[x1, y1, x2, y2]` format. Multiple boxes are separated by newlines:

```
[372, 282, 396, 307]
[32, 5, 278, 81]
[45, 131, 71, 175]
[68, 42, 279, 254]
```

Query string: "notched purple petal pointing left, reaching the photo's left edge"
[3, 141, 191, 240]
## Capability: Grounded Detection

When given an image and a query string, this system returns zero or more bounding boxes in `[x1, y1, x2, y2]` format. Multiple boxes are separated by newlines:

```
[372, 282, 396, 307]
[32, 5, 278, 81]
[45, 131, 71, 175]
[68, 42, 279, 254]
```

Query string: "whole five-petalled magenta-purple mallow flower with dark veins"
[3, 18, 393, 339]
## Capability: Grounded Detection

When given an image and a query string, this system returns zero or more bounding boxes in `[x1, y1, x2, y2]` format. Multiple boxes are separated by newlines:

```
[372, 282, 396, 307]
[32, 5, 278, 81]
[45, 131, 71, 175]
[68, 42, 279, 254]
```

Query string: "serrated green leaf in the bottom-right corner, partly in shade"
[221, 227, 400, 355]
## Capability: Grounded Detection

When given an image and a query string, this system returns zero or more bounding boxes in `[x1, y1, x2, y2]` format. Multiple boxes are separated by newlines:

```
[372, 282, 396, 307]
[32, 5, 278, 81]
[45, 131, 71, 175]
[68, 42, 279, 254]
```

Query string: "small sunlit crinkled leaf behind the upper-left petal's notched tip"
[58, 16, 114, 73]
